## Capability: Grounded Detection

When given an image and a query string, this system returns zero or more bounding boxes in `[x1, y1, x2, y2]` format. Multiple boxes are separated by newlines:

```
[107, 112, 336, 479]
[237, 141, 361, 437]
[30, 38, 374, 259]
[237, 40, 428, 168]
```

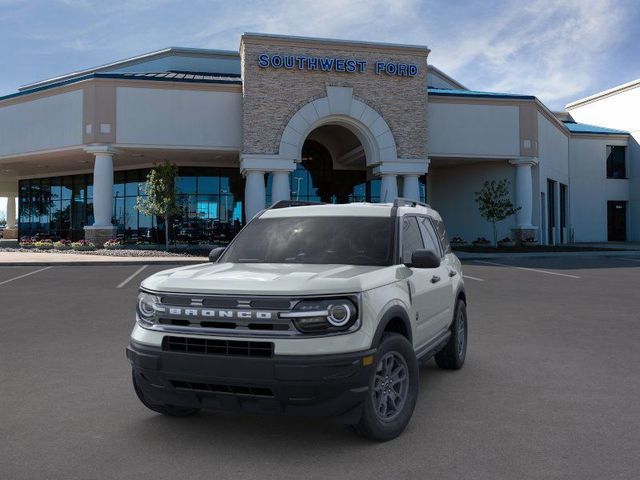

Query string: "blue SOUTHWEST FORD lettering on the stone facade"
[258, 53, 418, 77]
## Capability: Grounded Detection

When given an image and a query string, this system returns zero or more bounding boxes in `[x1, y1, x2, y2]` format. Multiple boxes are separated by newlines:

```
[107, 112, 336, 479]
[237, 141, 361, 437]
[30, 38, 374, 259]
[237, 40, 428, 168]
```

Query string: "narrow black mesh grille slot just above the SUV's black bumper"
[162, 337, 273, 357]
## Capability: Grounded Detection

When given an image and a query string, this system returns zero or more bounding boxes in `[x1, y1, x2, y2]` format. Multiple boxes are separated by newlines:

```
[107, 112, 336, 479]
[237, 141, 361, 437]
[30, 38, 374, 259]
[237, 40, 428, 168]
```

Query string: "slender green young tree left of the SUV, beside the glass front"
[136, 161, 180, 250]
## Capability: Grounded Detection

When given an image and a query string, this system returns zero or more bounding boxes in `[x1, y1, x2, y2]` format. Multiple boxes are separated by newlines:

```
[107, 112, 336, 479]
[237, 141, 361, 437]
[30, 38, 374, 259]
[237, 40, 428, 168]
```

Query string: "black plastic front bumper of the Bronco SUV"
[127, 341, 375, 423]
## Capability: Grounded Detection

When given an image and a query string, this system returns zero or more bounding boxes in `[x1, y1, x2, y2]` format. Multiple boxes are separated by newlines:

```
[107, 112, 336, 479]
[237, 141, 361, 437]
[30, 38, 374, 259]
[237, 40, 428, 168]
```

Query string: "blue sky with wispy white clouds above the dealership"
[0, 0, 640, 218]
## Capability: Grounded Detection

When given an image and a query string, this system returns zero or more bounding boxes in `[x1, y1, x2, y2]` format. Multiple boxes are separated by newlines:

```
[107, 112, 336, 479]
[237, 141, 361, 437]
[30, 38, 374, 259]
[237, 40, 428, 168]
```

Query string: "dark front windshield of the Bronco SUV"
[220, 216, 393, 265]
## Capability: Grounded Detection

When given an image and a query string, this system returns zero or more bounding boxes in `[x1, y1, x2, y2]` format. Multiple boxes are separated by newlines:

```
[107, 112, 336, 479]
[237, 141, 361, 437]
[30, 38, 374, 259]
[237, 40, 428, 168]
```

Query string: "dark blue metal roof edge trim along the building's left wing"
[0, 72, 242, 101]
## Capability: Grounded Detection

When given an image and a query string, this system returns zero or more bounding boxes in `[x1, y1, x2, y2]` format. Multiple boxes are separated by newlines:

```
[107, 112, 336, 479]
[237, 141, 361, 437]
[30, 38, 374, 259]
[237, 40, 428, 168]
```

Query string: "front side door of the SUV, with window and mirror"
[400, 215, 451, 347]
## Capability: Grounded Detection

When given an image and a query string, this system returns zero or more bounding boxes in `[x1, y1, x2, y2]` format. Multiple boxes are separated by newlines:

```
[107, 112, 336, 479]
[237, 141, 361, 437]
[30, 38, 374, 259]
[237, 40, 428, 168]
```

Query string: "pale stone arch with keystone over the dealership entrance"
[278, 87, 398, 165]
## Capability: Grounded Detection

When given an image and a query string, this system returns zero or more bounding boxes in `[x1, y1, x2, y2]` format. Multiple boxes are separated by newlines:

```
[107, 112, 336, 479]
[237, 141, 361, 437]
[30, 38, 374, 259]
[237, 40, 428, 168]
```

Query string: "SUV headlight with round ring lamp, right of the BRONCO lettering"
[280, 298, 358, 333]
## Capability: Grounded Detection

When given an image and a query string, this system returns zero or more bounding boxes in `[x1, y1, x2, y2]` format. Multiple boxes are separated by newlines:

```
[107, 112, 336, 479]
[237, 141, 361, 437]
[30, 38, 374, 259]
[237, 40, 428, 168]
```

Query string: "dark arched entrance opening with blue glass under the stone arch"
[291, 124, 380, 203]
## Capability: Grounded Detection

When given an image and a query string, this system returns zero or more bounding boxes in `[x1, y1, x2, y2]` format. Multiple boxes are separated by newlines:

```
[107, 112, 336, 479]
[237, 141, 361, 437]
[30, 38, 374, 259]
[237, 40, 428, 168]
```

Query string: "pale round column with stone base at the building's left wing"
[84, 145, 118, 247]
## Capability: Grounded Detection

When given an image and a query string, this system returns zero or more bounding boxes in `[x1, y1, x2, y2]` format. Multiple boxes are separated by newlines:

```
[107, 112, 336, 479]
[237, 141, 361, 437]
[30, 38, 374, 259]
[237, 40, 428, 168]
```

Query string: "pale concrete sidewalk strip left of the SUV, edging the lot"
[0, 252, 208, 267]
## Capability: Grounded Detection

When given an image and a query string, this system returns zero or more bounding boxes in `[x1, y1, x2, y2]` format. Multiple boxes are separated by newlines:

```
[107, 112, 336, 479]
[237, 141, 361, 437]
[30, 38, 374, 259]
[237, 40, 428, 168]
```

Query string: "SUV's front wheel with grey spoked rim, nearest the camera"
[351, 333, 418, 441]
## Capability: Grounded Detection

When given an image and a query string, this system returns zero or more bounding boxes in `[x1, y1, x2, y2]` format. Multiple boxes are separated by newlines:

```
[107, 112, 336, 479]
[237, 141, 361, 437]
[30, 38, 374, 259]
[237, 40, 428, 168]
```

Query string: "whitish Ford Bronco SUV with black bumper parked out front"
[127, 199, 467, 440]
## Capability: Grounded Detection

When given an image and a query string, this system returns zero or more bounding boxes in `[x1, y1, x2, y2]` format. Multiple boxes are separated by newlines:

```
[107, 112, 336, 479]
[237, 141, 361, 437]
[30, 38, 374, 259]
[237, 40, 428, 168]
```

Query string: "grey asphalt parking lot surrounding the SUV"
[0, 258, 640, 480]
